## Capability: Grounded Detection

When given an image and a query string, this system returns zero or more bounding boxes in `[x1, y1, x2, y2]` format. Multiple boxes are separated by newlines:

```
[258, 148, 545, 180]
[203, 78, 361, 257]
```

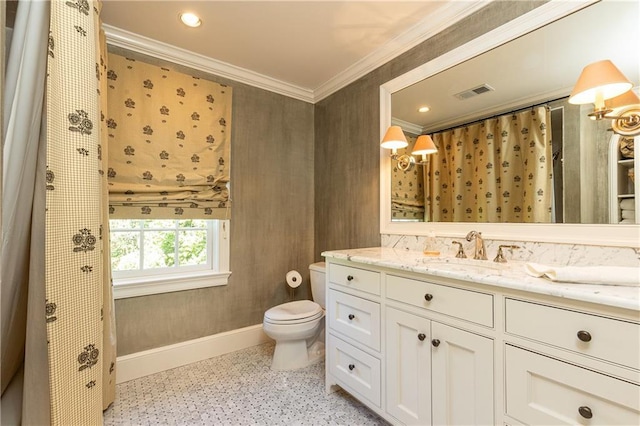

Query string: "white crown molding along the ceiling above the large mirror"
[313, 0, 492, 102]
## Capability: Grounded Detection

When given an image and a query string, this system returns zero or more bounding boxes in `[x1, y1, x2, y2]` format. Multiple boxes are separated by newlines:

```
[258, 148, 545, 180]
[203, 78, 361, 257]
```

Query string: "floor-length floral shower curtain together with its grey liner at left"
[0, 0, 115, 425]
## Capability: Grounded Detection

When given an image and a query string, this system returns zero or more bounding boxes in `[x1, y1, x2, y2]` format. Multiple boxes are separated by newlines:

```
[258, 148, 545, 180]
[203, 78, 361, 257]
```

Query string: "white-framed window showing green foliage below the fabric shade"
[109, 219, 230, 298]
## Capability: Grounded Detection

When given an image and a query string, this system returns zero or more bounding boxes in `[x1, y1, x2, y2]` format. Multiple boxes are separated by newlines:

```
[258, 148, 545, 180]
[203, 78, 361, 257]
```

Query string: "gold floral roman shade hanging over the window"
[105, 53, 232, 219]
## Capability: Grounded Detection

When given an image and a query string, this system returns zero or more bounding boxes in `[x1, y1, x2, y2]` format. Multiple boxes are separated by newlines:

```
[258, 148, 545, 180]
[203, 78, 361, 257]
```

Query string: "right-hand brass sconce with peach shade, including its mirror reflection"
[569, 59, 640, 136]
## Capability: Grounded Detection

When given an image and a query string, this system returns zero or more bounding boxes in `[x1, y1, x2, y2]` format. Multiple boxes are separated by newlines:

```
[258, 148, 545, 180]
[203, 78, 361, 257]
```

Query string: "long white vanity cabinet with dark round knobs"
[326, 252, 640, 426]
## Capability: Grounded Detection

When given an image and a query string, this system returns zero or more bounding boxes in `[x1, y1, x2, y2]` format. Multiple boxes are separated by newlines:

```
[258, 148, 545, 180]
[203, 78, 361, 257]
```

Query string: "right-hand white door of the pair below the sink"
[430, 322, 494, 425]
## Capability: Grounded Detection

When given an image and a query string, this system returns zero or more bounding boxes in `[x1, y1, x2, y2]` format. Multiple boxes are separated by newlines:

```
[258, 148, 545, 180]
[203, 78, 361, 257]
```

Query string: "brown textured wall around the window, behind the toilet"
[112, 49, 314, 356]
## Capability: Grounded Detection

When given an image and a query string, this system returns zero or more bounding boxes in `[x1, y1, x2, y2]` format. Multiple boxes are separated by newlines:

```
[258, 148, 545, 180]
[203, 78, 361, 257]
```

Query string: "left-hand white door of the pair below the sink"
[386, 308, 431, 425]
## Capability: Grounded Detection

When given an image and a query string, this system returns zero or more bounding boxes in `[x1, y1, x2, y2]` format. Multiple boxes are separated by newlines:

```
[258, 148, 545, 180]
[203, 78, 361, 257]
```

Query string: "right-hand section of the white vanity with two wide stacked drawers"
[505, 298, 640, 425]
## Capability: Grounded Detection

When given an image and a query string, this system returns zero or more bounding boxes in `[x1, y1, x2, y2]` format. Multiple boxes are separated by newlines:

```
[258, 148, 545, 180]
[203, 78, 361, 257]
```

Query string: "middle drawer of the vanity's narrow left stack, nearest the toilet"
[327, 289, 380, 351]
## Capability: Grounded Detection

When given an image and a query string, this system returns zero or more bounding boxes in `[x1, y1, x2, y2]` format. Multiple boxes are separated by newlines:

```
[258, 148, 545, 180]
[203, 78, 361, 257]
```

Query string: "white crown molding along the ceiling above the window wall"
[103, 24, 314, 103]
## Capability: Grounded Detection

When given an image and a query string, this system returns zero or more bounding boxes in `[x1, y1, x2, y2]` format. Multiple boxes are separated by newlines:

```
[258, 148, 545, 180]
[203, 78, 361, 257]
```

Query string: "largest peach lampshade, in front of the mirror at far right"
[569, 59, 633, 104]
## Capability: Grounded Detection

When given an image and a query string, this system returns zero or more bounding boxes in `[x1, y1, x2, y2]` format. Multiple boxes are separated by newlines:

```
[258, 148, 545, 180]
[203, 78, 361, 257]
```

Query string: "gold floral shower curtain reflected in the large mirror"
[425, 106, 553, 223]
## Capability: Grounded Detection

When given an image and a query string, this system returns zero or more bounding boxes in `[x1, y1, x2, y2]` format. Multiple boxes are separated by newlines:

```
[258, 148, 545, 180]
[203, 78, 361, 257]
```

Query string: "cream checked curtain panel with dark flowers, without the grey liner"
[45, 0, 115, 425]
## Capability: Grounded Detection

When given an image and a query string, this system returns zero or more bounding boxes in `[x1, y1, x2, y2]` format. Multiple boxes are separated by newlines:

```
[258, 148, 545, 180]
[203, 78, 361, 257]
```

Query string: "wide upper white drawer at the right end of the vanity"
[506, 299, 640, 369]
